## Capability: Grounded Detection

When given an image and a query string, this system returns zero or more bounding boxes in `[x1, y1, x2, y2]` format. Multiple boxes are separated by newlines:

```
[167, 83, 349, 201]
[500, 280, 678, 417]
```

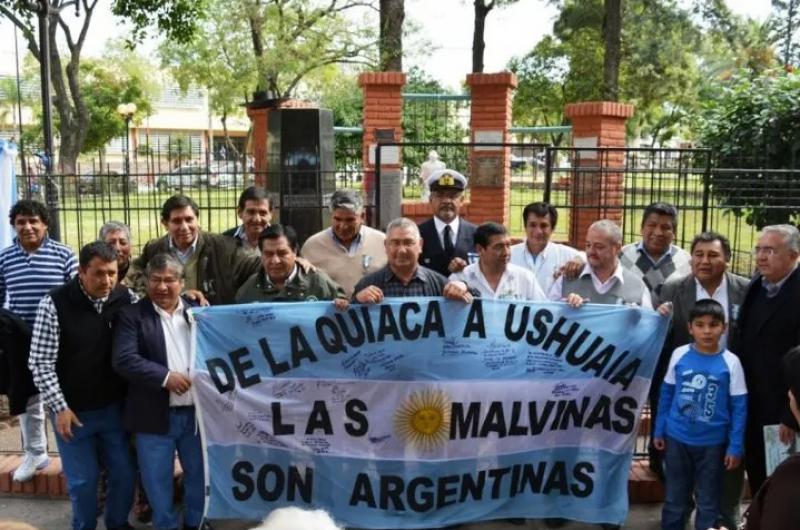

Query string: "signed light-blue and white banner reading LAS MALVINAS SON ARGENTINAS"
[192, 298, 668, 529]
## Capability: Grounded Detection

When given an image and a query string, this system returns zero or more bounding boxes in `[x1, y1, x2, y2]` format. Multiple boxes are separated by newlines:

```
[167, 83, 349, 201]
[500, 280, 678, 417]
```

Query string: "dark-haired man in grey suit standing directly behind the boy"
[650, 232, 750, 528]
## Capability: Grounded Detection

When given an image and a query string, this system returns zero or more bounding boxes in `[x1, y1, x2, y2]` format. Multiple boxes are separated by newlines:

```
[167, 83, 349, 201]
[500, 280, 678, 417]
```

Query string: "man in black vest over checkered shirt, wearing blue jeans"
[28, 241, 136, 530]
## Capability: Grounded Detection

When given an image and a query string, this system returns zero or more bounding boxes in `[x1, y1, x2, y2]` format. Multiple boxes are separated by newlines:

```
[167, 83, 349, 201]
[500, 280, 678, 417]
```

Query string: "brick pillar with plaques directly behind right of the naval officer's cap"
[467, 72, 517, 225]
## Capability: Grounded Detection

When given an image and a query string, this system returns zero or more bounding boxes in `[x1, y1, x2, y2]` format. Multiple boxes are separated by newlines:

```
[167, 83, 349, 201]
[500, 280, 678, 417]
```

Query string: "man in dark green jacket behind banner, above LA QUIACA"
[236, 224, 348, 309]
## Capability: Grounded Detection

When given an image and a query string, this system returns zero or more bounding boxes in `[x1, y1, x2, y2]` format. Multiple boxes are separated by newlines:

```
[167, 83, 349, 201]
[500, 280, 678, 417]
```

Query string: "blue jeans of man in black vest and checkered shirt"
[52, 404, 134, 530]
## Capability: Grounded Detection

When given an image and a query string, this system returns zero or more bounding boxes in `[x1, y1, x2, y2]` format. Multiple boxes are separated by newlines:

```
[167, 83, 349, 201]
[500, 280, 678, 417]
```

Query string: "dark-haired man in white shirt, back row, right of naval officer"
[511, 202, 580, 292]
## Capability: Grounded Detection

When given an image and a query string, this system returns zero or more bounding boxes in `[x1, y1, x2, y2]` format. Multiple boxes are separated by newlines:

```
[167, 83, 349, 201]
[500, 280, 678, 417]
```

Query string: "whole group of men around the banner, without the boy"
[0, 169, 800, 529]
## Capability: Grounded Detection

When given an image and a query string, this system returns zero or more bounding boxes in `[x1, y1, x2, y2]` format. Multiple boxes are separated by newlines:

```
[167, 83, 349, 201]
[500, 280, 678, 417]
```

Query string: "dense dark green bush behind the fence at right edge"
[698, 71, 800, 228]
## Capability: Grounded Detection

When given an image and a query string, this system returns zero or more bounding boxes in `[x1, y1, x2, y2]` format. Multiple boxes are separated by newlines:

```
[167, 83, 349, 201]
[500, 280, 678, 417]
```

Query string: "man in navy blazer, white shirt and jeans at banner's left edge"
[113, 253, 205, 530]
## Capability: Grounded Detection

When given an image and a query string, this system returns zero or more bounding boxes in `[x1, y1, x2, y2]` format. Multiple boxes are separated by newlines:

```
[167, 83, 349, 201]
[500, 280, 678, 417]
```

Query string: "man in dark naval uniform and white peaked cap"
[419, 169, 476, 276]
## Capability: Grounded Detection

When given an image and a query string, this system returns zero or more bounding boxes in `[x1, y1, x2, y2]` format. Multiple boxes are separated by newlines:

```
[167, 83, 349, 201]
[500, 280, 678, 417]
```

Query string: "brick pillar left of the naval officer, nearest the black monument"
[358, 72, 406, 223]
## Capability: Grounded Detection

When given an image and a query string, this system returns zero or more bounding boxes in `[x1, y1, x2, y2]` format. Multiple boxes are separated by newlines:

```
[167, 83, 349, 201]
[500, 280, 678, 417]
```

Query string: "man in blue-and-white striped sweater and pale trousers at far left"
[0, 200, 78, 482]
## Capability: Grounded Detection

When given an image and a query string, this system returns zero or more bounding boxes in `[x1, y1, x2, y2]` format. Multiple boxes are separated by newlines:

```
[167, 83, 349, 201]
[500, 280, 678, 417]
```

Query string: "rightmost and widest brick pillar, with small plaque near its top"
[564, 101, 633, 248]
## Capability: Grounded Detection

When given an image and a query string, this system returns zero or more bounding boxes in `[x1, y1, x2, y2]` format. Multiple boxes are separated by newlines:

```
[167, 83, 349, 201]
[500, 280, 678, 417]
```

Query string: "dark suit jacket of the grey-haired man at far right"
[731, 268, 800, 429]
